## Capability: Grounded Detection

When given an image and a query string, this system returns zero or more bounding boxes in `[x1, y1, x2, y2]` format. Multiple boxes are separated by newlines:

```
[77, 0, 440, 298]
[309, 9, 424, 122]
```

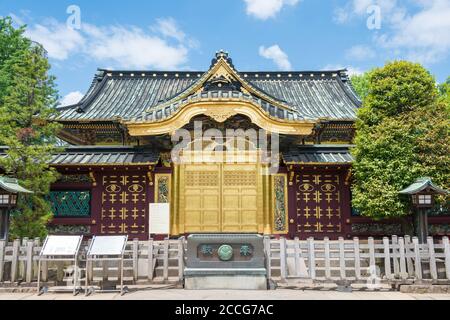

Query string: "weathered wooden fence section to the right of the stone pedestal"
[265, 236, 450, 283]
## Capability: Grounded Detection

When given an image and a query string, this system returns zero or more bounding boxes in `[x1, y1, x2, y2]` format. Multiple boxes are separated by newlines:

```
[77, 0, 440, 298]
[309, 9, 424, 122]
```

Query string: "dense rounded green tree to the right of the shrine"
[352, 61, 450, 219]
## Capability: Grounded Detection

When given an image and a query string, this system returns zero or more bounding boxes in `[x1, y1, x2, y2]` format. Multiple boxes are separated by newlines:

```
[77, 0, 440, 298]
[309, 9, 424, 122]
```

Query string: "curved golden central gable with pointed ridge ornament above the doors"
[125, 51, 315, 136]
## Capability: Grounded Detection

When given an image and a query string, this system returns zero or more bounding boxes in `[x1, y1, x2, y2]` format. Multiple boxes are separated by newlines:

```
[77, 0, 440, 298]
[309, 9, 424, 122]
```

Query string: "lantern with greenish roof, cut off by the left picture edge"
[0, 176, 33, 240]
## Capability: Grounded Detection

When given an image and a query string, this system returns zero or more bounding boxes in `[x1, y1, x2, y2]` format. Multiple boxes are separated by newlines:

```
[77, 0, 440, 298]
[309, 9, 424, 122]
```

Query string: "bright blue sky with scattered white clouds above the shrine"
[0, 0, 450, 104]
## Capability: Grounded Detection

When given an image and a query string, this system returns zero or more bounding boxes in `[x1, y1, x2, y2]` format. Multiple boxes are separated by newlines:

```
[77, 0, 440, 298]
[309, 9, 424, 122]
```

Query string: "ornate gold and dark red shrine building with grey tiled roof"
[0, 51, 446, 239]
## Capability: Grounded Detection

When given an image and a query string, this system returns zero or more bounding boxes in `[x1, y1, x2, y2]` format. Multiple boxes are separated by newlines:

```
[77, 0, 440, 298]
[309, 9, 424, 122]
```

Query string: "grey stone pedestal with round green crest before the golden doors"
[184, 234, 267, 290]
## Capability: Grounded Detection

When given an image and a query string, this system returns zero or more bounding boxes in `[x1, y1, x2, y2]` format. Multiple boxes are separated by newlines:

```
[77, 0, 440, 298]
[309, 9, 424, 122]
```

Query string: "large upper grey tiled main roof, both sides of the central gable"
[54, 70, 360, 121]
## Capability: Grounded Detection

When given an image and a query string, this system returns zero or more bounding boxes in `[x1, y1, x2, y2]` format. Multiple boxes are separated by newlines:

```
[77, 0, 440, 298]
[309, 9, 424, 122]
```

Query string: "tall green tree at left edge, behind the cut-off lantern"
[0, 18, 59, 238]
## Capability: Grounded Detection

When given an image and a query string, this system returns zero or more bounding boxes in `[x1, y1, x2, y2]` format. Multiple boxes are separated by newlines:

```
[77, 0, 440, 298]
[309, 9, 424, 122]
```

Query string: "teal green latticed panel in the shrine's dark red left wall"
[48, 190, 91, 217]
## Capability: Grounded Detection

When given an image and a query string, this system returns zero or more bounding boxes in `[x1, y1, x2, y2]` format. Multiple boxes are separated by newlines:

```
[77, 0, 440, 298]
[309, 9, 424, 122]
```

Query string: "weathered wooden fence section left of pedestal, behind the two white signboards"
[0, 237, 185, 286]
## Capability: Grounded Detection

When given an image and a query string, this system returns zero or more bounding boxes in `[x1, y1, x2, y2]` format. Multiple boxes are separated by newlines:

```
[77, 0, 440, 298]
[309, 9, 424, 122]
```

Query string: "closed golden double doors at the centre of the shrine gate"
[180, 163, 263, 233]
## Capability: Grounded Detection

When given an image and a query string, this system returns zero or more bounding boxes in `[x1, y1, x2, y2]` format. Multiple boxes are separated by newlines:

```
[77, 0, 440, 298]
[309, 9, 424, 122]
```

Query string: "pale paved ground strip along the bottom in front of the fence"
[0, 289, 450, 300]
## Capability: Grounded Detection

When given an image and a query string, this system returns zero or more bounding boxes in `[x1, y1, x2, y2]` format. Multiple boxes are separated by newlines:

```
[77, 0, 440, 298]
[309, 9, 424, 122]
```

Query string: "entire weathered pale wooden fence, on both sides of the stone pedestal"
[0, 236, 450, 286]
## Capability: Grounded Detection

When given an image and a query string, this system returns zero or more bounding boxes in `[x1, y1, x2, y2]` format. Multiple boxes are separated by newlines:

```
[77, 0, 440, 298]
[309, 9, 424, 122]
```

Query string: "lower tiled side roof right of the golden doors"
[282, 145, 353, 164]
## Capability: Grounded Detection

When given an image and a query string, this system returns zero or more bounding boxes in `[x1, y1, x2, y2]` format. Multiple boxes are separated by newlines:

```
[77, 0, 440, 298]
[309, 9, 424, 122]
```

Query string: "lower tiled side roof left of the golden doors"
[0, 146, 159, 166]
